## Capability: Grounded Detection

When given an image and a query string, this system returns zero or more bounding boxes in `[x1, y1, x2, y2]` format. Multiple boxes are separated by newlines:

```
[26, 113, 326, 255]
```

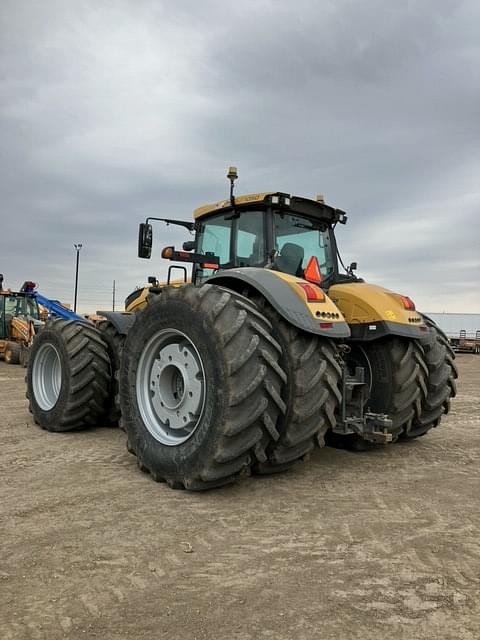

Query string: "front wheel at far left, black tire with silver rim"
[26, 320, 111, 431]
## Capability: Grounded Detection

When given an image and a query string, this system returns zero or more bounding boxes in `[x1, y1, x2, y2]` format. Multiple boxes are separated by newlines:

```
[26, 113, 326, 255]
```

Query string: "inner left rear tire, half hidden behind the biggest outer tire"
[251, 300, 342, 474]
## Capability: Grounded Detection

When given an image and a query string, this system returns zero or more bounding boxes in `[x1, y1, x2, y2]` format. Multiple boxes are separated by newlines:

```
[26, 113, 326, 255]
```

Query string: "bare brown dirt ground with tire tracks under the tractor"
[0, 355, 480, 640]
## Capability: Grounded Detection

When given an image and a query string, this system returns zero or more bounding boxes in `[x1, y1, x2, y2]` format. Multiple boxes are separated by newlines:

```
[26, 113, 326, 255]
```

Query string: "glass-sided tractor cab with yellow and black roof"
[194, 193, 345, 285]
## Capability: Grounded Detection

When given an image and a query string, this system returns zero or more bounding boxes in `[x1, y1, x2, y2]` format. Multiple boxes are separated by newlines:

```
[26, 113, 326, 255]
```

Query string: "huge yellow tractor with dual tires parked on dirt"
[27, 167, 457, 490]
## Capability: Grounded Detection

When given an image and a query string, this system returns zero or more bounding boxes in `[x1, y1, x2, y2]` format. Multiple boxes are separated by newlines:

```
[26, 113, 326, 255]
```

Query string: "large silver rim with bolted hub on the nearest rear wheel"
[136, 329, 205, 447]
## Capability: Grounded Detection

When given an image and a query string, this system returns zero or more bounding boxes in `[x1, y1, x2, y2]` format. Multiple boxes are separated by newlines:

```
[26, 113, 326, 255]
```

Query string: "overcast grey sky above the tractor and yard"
[0, 0, 480, 313]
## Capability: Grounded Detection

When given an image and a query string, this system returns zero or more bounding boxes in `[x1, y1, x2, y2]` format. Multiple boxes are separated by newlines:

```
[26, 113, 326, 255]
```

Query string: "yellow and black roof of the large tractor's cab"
[193, 191, 347, 224]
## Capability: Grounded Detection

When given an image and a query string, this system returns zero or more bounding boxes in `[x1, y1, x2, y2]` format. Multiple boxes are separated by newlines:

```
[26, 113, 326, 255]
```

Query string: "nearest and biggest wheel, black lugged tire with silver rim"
[119, 284, 286, 490]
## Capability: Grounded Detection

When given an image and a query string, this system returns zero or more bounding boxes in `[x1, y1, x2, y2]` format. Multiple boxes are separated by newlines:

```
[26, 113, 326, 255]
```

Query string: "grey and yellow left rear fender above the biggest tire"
[207, 267, 350, 338]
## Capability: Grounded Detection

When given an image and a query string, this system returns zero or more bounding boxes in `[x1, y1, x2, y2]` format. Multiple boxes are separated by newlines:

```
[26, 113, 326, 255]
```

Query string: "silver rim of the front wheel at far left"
[32, 343, 62, 411]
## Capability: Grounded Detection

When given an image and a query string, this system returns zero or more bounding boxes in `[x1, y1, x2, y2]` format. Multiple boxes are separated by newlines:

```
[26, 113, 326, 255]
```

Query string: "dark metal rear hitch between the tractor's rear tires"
[333, 365, 392, 444]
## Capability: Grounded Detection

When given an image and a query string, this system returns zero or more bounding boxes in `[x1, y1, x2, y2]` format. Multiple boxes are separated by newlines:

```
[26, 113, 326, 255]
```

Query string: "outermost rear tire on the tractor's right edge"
[402, 316, 458, 439]
